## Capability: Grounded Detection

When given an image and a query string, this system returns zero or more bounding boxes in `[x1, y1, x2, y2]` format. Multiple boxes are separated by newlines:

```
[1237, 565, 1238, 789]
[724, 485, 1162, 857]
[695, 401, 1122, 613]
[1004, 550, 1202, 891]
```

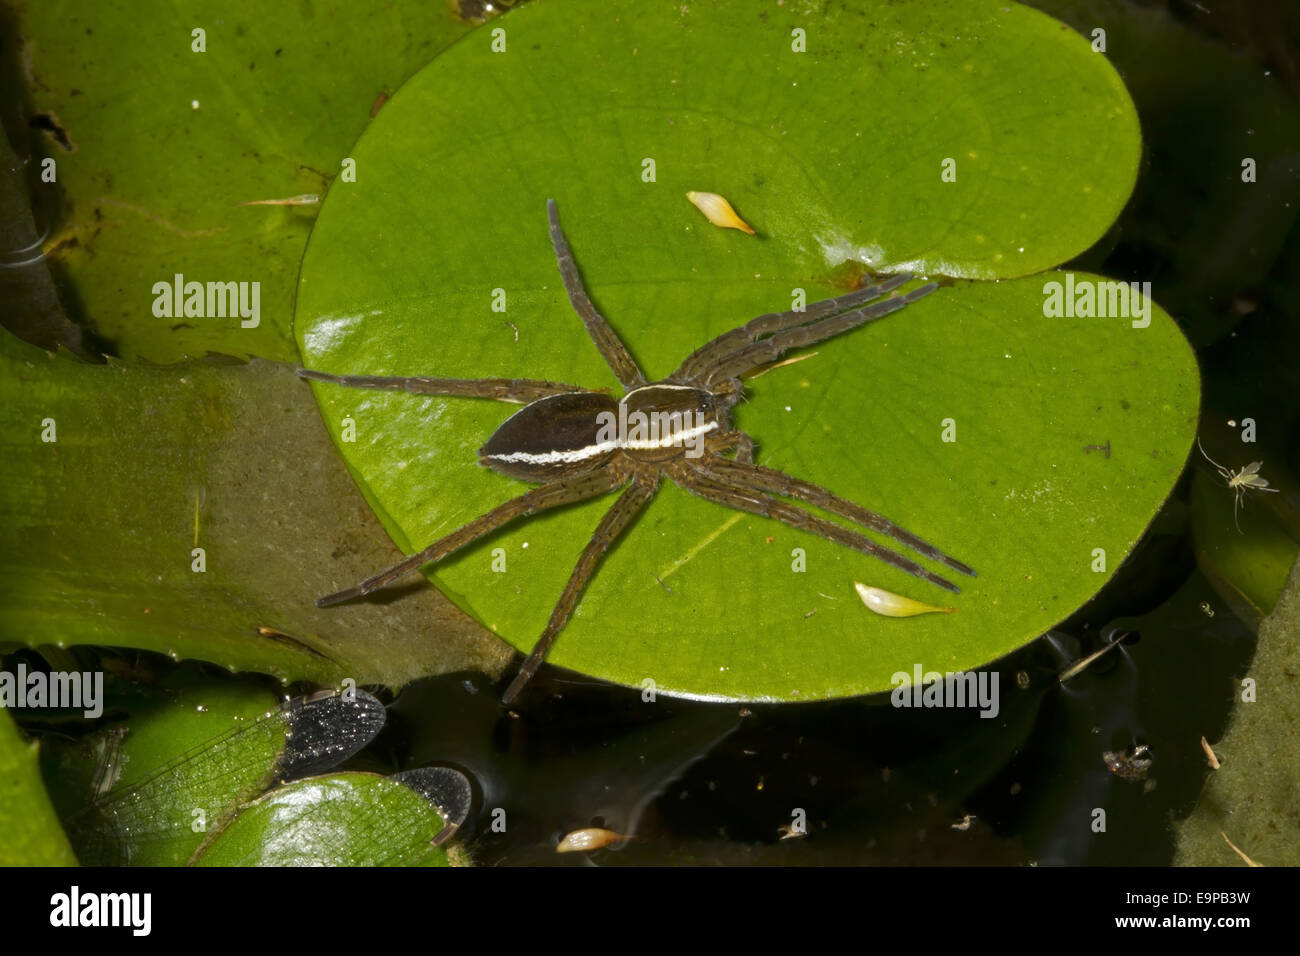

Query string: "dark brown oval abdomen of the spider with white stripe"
[478, 392, 619, 481]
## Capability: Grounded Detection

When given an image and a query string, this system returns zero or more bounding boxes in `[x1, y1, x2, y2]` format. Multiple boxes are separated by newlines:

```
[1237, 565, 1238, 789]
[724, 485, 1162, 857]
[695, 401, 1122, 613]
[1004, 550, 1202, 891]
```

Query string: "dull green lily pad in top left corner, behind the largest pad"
[14, 0, 471, 363]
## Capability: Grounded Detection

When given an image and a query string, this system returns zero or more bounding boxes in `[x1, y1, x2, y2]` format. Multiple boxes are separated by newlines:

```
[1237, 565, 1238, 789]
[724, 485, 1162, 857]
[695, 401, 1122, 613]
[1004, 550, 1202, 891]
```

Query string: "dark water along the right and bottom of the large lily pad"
[7, 3, 1300, 865]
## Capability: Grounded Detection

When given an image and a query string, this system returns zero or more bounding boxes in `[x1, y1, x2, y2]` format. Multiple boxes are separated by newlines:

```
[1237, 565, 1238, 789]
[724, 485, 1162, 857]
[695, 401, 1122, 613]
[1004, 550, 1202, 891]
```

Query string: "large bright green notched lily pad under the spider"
[296, 4, 1199, 700]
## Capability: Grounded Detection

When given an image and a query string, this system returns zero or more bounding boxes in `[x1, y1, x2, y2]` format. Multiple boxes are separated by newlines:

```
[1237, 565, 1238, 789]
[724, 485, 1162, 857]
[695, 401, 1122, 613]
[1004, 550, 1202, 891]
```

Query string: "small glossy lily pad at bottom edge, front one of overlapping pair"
[195, 773, 447, 866]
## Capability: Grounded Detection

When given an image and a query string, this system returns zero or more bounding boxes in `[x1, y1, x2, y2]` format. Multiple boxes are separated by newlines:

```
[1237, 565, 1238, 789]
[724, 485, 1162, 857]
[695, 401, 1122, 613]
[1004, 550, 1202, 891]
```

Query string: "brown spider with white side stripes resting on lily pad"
[298, 199, 975, 705]
